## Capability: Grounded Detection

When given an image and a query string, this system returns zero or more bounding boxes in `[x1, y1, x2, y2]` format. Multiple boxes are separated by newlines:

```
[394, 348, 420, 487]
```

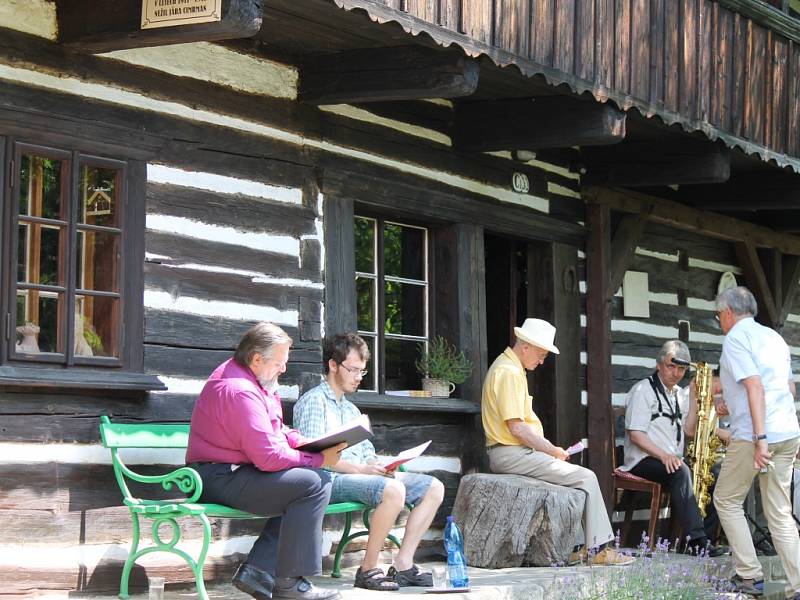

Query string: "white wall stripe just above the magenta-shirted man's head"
[144, 289, 299, 327]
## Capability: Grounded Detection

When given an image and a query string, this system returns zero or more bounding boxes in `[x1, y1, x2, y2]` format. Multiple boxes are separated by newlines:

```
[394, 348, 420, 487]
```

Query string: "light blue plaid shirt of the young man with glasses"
[293, 381, 378, 477]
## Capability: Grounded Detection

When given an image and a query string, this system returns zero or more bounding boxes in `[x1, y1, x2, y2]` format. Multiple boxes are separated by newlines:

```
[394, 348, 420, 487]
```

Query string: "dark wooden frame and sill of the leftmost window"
[0, 133, 165, 391]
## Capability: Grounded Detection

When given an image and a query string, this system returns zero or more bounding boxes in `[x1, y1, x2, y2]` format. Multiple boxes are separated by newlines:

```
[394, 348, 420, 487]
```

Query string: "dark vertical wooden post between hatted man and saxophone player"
[586, 200, 614, 511]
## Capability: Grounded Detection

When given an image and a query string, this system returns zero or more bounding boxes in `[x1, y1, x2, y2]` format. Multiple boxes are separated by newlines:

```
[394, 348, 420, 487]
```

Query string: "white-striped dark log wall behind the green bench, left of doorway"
[0, 0, 582, 593]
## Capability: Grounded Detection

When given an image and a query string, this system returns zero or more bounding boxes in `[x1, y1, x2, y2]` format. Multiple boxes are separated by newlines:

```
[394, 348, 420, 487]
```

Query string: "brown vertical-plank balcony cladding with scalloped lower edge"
[346, 0, 800, 170]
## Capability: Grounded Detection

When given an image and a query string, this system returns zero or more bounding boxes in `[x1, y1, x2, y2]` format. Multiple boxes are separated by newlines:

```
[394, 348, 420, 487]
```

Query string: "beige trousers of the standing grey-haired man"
[714, 438, 800, 598]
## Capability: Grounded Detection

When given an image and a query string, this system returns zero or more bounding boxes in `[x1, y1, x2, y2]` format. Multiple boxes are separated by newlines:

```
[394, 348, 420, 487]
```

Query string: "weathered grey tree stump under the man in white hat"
[453, 473, 586, 569]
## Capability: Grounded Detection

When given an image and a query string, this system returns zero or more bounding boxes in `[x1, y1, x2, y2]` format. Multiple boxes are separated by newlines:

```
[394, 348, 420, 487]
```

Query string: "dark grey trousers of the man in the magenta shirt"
[191, 463, 331, 577]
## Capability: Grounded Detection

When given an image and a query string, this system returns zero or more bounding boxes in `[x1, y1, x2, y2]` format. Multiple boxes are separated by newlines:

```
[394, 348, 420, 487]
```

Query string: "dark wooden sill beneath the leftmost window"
[0, 366, 167, 392]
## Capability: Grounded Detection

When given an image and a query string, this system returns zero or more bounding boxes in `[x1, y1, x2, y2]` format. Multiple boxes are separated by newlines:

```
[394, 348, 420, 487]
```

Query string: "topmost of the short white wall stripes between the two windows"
[147, 163, 303, 205]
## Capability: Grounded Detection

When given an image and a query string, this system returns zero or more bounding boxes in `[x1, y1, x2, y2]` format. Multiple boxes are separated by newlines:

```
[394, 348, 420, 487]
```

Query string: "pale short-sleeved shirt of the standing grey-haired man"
[719, 317, 800, 444]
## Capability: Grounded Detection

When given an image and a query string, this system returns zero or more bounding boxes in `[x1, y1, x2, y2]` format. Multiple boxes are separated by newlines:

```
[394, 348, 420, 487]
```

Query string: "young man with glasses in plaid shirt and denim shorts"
[294, 333, 444, 591]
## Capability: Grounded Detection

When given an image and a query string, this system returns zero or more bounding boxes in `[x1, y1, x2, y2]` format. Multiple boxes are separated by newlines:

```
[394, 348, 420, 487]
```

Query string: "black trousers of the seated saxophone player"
[631, 456, 716, 542]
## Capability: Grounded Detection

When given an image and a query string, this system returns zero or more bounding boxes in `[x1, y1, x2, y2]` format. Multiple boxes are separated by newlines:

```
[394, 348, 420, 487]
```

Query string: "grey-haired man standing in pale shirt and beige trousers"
[714, 287, 800, 599]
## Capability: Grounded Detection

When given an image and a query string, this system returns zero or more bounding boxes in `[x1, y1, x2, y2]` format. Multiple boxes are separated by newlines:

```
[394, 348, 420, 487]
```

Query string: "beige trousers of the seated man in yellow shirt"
[489, 446, 614, 548]
